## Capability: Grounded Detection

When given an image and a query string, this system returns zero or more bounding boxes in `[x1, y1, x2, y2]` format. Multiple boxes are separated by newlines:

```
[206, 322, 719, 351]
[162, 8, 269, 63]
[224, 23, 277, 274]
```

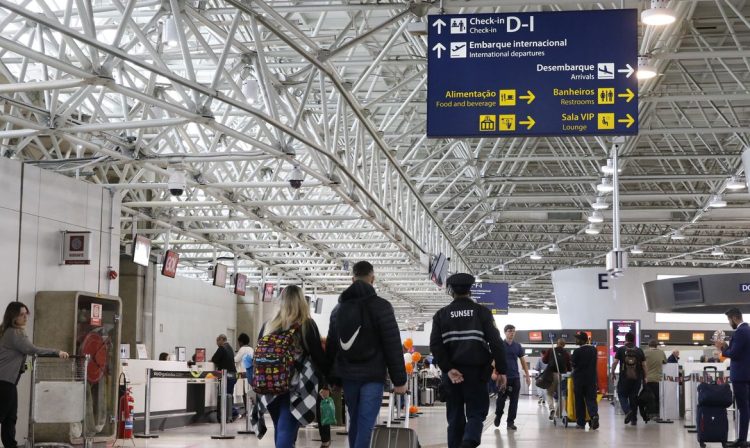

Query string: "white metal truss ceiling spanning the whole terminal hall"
[0, 0, 750, 323]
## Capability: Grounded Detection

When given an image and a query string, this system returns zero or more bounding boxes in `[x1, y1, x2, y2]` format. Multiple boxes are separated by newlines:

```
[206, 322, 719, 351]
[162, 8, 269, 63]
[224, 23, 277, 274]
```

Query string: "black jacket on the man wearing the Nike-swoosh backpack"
[326, 280, 406, 386]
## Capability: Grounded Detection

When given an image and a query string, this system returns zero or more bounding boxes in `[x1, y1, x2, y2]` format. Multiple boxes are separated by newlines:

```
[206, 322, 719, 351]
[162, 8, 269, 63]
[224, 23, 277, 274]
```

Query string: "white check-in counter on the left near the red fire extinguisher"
[121, 359, 218, 432]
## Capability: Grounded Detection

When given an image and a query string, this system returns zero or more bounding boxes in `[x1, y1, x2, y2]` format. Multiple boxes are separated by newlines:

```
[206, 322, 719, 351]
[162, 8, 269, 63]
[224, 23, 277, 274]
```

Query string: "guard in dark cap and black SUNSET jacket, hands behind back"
[430, 274, 506, 448]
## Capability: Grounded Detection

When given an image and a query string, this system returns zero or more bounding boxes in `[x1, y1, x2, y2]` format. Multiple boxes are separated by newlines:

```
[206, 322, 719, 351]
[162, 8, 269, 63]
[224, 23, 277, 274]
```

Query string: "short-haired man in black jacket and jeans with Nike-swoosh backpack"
[326, 261, 406, 448]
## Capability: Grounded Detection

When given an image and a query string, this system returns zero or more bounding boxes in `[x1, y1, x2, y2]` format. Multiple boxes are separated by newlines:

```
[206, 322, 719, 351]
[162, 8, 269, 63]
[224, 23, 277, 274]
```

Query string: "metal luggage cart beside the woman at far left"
[26, 355, 91, 448]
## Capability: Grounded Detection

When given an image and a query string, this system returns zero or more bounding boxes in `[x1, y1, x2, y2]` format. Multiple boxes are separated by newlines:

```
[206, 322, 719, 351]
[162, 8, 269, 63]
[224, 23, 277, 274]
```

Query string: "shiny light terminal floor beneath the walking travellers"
[122, 396, 733, 448]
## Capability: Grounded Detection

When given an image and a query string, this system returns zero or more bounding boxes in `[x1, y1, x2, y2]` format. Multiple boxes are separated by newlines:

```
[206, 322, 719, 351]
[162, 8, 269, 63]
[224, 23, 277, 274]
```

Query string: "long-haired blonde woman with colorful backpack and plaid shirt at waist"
[252, 285, 328, 448]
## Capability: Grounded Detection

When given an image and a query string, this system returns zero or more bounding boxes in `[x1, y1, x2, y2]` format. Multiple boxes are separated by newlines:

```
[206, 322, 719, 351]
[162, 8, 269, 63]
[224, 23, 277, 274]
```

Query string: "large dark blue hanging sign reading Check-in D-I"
[427, 9, 638, 137]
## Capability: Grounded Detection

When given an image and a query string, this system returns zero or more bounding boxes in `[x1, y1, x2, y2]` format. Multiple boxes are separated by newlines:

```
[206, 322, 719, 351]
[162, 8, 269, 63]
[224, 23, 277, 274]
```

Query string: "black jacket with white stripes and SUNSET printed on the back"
[430, 297, 507, 374]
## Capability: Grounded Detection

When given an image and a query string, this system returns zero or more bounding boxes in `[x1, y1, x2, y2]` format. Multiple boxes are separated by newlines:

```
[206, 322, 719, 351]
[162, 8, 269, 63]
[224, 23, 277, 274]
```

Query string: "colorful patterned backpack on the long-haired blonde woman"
[251, 325, 300, 395]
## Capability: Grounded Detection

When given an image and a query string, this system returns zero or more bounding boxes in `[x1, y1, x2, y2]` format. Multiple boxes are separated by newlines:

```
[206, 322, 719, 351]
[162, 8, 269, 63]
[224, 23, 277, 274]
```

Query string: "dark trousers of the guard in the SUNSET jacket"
[443, 369, 490, 448]
